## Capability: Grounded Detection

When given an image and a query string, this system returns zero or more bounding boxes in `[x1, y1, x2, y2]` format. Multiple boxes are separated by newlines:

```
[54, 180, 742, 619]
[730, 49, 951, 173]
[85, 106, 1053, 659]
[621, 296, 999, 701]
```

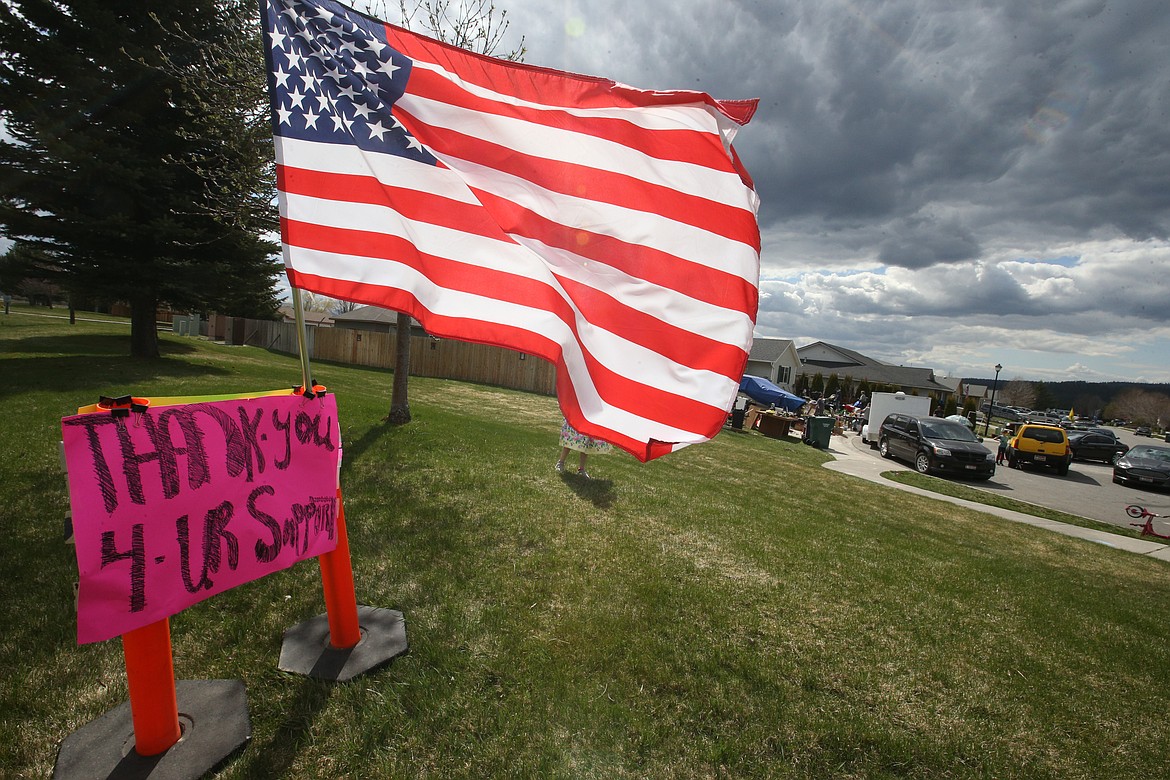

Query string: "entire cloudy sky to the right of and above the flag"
[477, 0, 1170, 382]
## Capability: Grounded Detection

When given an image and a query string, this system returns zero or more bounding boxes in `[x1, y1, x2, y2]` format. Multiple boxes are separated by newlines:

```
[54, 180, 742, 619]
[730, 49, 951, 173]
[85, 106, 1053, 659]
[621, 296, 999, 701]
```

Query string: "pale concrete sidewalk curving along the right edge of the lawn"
[825, 433, 1170, 561]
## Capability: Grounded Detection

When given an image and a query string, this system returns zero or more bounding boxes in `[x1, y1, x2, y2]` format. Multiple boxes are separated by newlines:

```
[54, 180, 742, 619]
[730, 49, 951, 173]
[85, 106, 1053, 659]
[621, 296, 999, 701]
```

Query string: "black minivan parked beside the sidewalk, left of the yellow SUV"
[878, 414, 996, 479]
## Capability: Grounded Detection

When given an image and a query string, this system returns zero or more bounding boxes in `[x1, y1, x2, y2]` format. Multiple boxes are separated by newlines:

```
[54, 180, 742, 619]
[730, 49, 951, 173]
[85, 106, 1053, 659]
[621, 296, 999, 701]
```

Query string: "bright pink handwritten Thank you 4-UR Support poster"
[61, 394, 342, 644]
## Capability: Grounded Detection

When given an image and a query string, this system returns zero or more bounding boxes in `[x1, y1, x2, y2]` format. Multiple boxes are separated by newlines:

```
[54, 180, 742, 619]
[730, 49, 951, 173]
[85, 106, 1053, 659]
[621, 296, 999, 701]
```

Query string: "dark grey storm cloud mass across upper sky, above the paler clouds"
[512, 0, 1170, 268]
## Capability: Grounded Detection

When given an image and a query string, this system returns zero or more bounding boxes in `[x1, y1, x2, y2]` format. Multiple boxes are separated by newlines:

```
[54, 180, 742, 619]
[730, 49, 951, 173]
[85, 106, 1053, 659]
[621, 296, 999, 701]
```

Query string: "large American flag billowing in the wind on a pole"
[264, 0, 759, 461]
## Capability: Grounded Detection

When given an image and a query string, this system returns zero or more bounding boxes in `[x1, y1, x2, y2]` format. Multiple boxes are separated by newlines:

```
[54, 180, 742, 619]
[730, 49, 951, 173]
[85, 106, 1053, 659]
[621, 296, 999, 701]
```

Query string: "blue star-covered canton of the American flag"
[264, 0, 436, 165]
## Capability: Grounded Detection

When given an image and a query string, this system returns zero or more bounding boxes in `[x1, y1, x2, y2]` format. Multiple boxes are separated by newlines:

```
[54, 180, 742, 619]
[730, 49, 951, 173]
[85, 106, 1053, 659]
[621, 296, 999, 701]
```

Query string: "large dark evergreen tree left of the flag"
[0, 0, 280, 357]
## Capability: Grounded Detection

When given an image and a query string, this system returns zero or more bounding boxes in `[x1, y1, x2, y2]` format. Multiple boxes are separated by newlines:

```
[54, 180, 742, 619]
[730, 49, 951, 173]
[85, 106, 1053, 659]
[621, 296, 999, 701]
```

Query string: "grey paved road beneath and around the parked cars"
[849, 429, 1170, 533]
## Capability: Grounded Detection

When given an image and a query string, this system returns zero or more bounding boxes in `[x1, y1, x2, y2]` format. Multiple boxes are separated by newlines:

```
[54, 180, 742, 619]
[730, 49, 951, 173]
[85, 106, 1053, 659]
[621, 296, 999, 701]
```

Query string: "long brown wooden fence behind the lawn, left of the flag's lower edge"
[198, 316, 557, 395]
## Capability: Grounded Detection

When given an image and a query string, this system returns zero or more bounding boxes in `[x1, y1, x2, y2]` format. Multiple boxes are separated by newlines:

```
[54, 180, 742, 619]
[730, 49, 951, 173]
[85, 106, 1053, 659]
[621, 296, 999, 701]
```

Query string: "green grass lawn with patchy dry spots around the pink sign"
[0, 309, 1170, 779]
